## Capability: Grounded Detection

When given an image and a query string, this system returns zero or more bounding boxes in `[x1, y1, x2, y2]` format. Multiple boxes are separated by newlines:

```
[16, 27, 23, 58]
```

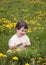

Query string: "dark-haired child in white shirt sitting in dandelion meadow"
[8, 21, 30, 53]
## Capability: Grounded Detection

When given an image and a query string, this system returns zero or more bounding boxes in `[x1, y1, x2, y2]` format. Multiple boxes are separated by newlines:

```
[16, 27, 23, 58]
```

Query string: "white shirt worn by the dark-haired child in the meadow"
[8, 34, 30, 49]
